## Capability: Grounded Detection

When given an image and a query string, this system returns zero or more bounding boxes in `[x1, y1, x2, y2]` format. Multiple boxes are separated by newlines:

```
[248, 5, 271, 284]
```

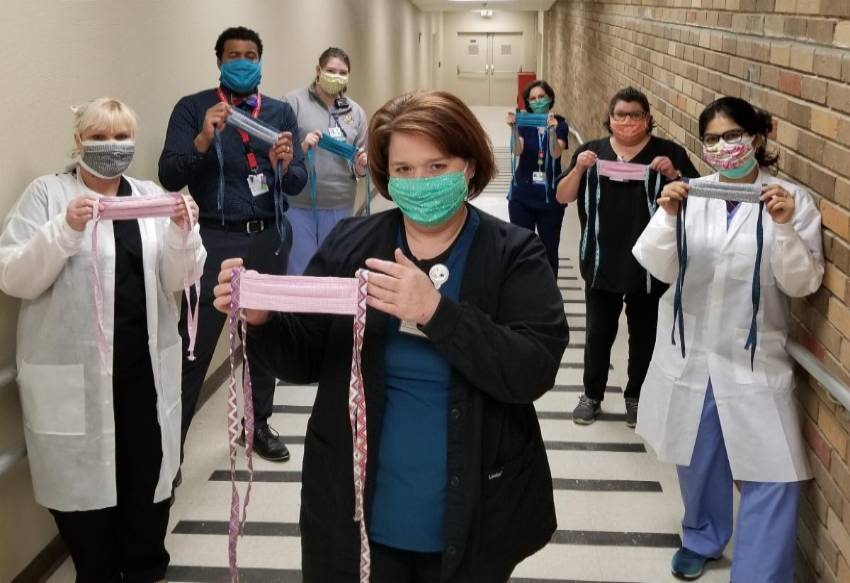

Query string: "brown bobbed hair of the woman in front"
[367, 91, 497, 199]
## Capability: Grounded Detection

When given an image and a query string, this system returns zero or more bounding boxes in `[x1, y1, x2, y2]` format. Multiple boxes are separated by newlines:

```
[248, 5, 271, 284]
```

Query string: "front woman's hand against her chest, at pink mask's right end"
[366, 249, 440, 326]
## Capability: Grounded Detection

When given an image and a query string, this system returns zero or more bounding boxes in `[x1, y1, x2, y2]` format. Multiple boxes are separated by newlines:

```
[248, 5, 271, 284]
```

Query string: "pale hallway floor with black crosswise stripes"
[50, 108, 729, 583]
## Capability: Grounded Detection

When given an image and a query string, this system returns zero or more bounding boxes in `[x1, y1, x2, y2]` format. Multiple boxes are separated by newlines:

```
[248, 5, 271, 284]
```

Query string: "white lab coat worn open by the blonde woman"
[0, 173, 206, 511]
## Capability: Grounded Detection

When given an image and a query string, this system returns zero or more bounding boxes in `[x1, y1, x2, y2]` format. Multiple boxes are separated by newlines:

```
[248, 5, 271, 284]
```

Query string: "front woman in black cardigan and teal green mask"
[215, 92, 569, 583]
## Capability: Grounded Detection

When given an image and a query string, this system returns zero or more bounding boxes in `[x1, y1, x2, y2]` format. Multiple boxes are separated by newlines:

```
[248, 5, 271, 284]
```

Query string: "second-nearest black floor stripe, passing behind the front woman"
[172, 524, 681, 544]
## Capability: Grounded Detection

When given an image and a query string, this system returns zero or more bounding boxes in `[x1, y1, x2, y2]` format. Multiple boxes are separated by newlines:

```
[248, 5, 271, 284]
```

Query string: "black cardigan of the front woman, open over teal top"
[248, 205, 569, 583]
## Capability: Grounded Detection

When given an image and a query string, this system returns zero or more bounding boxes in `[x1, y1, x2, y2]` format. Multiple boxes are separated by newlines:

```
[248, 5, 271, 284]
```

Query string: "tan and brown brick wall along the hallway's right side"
[544, 0, 850, 583]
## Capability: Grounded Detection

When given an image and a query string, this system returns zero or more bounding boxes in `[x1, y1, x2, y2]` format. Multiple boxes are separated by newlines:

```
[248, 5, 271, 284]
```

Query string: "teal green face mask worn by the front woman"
[387, 171, 469, 227]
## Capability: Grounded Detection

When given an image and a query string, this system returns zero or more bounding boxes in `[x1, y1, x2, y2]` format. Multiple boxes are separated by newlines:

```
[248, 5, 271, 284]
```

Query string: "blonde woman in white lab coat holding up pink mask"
[0, 97, 206, 583]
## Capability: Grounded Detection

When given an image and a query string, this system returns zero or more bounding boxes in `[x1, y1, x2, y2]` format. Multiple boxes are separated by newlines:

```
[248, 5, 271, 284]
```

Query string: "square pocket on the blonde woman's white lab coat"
[18, 361, 86, 435]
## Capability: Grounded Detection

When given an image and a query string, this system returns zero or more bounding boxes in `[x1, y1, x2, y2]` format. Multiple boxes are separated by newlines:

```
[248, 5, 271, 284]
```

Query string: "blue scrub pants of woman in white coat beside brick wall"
[677, 381, 800, 583]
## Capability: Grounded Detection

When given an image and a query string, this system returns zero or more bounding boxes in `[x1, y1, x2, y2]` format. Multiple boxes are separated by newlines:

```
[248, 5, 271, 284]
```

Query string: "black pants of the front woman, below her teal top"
[302, 542, 510, 583]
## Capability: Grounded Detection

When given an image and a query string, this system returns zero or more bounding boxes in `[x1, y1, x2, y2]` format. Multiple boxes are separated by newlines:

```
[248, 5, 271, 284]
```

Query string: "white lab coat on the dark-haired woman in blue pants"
[632, 170, 824, 482]
